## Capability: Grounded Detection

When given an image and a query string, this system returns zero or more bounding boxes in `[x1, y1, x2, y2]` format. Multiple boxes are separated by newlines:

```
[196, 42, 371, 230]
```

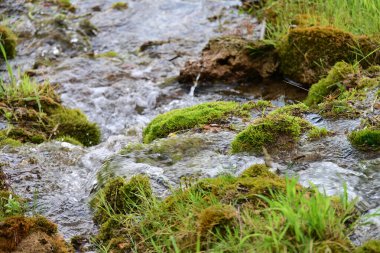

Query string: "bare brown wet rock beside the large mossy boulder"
[179, 36, 279, 85]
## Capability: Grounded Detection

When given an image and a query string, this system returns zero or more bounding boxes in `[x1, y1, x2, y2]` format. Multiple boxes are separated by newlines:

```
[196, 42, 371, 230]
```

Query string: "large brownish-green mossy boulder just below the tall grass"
[278, 26, 380, 86]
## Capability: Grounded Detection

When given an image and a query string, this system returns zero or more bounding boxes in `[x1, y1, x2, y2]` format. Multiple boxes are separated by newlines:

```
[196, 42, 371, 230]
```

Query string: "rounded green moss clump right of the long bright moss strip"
[231, 114, 312, 154]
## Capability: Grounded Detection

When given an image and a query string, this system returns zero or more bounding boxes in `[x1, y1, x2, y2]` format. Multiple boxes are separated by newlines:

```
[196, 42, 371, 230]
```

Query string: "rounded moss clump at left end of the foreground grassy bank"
[91, 175, 152, 224]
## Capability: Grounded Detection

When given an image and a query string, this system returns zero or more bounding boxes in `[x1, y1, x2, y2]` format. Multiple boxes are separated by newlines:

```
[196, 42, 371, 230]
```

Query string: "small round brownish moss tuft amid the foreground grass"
[197, 205, 237, 237]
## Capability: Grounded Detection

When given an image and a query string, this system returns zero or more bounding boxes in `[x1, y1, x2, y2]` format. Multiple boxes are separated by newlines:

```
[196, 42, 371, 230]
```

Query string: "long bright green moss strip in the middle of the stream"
[143, 101, 247, 143]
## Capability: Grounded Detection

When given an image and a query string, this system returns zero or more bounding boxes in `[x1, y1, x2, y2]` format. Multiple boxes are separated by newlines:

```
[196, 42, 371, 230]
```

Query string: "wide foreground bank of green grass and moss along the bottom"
[93, 165, 366, 252]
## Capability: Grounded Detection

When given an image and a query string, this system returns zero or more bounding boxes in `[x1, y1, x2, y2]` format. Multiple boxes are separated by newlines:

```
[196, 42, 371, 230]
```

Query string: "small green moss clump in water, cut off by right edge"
[348, 129, 380, 150]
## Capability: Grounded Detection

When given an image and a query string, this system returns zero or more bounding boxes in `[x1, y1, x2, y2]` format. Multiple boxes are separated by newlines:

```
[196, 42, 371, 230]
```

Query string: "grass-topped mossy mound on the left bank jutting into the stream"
[0, 47, 100, 146]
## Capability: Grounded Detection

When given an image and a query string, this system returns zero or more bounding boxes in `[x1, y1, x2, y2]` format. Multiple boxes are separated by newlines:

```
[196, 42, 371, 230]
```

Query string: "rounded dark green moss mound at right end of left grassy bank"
[50, 108, 100, 146]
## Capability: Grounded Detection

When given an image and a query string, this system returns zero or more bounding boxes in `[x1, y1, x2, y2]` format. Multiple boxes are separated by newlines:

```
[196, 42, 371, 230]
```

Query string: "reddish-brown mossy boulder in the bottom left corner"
[0, 216, 70, 253]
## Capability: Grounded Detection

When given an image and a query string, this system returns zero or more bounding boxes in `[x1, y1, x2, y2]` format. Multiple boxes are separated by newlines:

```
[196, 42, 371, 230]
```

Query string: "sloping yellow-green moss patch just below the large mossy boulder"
[304, 62, 358, 106]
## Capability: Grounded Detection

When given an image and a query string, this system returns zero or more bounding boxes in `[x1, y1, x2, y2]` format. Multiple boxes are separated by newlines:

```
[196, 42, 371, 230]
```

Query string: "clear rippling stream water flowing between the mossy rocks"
[0, 0, 380, 246]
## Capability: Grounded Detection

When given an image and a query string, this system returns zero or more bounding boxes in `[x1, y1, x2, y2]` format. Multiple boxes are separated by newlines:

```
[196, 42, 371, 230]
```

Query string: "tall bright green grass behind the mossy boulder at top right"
[251, 0, 380, 41]
